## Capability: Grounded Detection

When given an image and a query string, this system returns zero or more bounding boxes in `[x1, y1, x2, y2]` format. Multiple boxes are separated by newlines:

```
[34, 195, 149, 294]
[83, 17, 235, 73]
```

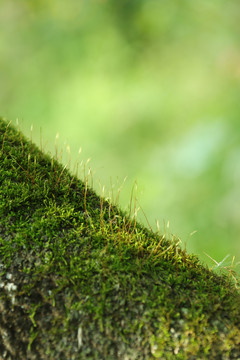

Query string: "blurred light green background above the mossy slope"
[0, 0, 240, 266]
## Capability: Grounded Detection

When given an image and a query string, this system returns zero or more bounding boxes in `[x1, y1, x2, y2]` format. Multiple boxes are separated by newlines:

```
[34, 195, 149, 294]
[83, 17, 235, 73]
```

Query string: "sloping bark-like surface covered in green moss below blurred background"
[0, 119, 240, 360]
